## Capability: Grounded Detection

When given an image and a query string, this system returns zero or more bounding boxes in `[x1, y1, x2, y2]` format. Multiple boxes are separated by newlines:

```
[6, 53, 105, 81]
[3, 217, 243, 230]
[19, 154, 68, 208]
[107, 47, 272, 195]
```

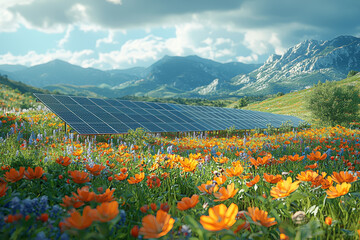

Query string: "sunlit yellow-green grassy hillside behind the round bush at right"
[243, 73, 360, 124]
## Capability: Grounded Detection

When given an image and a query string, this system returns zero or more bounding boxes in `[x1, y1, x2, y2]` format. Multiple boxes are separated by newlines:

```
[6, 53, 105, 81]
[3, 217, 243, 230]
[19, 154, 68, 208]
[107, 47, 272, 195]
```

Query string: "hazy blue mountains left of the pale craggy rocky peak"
[0, 56, 261, 97]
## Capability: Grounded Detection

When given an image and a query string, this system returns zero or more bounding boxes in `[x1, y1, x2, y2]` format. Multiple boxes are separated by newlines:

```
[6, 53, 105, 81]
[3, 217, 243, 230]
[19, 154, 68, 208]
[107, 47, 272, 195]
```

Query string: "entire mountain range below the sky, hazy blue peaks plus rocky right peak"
[0, 36, 360, 97]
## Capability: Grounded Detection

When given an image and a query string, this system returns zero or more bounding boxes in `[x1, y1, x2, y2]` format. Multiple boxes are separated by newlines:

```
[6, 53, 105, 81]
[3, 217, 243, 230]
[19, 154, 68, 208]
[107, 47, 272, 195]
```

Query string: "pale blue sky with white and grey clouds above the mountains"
[0, 0, 360, 70]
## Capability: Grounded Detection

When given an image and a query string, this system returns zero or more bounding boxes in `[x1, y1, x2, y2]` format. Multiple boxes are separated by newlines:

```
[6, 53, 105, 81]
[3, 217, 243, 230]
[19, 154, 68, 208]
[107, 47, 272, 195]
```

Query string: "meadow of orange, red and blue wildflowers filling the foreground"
[0, 91, 360, 239]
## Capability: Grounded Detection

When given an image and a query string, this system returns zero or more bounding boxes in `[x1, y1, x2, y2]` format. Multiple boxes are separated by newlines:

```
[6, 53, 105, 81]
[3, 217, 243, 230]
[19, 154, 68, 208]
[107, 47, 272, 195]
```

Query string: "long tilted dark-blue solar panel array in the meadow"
[34, 93, 301, 135]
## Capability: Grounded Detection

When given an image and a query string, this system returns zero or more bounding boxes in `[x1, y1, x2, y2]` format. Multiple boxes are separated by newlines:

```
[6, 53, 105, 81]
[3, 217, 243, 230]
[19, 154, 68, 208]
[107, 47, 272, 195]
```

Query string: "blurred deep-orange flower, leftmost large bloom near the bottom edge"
[64, 206, 96, 230]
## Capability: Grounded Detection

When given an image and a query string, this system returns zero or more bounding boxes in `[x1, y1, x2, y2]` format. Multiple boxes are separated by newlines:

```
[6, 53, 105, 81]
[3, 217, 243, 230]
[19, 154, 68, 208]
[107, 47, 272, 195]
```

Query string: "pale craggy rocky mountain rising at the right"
[231, 36, 360, 95]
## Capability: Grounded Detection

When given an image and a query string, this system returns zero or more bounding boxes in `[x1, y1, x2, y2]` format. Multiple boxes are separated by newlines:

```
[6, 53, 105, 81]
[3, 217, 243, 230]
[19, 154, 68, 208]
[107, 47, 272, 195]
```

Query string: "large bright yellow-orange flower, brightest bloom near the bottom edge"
[200, 203, 239, 231]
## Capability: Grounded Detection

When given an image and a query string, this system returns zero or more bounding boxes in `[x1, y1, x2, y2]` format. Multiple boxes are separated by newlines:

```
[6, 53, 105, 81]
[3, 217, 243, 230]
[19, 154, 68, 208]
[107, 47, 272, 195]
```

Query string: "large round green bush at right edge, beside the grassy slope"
[308, 82, 360, 126]
